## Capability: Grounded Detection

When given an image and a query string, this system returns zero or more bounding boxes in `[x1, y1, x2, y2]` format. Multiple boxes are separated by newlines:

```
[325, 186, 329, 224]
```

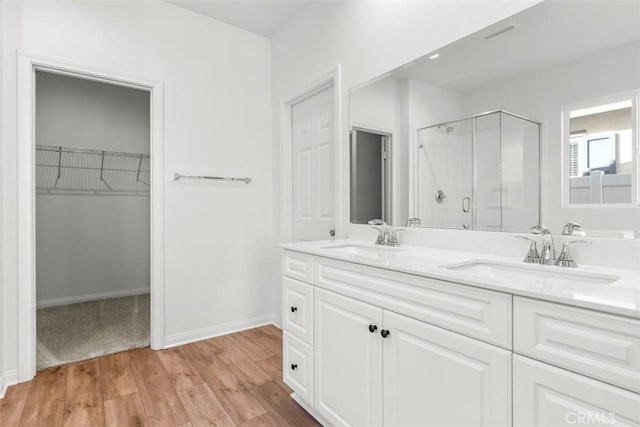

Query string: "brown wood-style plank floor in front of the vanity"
[0, 326, 318, 427]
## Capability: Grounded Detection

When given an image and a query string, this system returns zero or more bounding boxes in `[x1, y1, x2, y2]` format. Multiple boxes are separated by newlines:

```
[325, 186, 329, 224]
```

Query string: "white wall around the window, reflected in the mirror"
[462, 44, 640, 236]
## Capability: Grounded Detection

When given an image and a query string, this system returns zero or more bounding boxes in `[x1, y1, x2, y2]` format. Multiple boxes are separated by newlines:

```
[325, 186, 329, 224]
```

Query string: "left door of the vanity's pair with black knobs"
[314, 288, 383, 427]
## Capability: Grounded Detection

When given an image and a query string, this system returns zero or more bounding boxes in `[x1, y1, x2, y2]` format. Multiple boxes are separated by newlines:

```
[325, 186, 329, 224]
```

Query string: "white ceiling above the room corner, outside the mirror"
[168, 0, 321, 38]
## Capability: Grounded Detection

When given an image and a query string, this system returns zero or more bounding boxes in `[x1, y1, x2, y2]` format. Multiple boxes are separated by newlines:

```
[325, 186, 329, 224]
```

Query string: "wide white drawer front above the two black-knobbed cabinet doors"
[313, 257, 512, 349]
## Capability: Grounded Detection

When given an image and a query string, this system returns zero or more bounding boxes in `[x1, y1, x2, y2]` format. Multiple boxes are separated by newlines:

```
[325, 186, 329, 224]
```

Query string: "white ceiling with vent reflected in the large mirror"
[389, 0, 640, 93]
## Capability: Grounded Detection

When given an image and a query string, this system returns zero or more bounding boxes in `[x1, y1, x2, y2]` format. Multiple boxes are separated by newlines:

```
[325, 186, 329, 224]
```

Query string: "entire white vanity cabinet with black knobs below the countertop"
[283, 251, 640, 427]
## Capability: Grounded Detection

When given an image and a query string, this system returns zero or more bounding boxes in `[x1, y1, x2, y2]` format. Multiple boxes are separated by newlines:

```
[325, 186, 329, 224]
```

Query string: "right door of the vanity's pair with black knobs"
[383, 311, 511, 427]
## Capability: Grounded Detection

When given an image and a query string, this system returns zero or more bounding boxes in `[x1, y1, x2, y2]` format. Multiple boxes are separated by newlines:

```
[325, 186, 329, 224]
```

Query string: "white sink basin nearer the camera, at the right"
[443, 260, 620, 286]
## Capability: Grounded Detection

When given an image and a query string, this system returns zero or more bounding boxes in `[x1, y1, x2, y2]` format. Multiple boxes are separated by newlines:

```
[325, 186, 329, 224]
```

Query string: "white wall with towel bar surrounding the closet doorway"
[2, 2, 280, 382]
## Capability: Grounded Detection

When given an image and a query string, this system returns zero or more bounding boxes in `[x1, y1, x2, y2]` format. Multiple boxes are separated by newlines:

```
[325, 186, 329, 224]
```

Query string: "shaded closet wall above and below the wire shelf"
[36, 72, 150, 306]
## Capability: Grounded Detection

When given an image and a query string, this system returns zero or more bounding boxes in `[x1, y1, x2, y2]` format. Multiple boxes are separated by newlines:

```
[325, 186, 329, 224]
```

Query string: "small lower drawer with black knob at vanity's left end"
[282, 331, 313, 405]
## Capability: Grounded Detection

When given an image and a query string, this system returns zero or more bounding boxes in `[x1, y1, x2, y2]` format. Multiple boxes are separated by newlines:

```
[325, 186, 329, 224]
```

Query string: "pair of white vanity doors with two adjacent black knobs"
[314, 289, 511, 427]
